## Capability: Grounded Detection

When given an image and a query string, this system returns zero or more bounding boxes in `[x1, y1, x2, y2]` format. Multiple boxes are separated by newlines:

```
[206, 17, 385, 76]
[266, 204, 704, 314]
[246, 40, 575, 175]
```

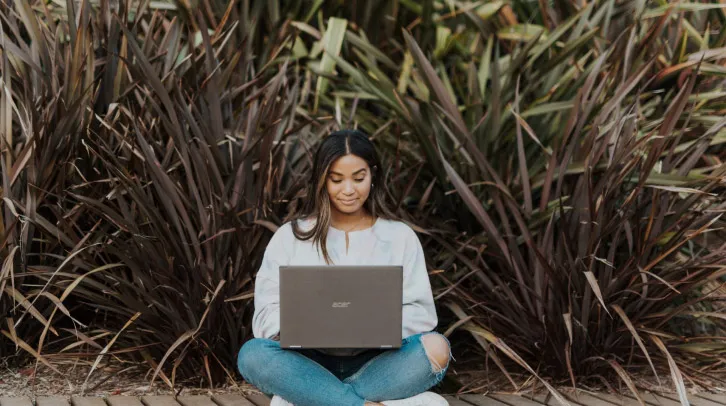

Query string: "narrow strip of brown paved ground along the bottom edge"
[0, 392, 726, 406]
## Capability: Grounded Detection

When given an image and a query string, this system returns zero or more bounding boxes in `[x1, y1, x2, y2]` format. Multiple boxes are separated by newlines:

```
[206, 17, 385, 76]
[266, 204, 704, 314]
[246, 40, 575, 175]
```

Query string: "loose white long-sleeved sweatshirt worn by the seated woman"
[252, 218, 438, 355]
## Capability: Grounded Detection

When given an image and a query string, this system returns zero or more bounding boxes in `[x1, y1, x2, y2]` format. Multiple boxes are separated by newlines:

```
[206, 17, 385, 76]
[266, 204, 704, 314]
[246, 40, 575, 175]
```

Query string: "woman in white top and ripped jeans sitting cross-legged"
[238, 130, 451, 406]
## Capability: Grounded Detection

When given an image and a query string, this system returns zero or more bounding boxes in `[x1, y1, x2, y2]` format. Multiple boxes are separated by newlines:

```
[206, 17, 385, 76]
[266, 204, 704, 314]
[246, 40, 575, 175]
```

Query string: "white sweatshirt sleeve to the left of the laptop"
[252, 224, 291, 339]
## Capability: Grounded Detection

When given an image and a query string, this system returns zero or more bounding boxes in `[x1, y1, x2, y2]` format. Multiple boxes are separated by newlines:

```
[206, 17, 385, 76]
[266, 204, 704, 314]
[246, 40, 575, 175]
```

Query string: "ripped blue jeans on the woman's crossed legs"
[237, 332, 456, 406]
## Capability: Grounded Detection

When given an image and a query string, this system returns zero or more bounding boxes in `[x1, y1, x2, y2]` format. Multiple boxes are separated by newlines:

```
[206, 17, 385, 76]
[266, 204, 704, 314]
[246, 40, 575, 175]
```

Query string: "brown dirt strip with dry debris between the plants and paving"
[0, 360, 726, 399]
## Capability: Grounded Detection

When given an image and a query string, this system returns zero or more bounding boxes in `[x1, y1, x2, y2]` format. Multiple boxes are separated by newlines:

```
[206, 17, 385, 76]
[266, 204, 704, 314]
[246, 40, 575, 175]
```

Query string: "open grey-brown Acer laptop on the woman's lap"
[280, 265, 403, 349]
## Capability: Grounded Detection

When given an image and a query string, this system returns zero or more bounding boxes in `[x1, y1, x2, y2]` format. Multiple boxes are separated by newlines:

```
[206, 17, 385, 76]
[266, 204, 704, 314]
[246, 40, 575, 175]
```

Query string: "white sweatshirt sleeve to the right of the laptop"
[401, 228, 439, 338]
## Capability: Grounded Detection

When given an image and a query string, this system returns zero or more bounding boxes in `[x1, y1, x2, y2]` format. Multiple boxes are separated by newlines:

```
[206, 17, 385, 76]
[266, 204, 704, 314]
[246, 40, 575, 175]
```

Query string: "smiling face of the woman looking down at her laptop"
[325, 154, 373, 214]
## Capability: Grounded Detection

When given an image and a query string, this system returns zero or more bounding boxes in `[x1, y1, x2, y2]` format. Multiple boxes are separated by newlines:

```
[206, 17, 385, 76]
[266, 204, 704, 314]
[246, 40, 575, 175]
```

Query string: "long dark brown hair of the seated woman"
[291, 130, 398, 264]
